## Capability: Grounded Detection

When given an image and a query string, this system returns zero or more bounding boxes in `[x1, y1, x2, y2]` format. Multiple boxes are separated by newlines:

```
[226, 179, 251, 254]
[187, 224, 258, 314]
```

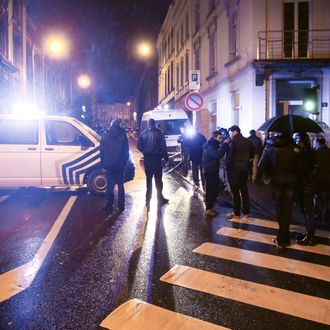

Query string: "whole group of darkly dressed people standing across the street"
[100, 119, 330, 247]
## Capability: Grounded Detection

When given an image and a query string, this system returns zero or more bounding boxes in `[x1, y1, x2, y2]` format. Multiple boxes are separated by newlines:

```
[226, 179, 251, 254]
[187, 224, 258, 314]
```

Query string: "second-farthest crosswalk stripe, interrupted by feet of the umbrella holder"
[217, 227, 330, 256]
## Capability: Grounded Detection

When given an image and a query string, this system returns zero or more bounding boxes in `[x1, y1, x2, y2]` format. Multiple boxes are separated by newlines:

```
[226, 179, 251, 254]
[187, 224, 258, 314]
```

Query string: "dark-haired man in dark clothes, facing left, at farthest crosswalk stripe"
[226, 125, 254, 219]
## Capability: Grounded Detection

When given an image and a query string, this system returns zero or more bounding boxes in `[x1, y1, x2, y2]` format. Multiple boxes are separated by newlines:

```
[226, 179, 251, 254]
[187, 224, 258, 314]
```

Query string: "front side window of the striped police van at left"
[45, 120, 86, 146]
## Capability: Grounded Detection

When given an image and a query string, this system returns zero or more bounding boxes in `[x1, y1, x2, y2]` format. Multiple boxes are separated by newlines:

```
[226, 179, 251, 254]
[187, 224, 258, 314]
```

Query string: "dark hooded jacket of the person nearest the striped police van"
[100, 125, 129, 169]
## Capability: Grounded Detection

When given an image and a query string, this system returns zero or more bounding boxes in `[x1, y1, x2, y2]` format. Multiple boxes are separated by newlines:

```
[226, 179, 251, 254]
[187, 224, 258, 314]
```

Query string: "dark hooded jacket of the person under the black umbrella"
[258, 136, 300, 185]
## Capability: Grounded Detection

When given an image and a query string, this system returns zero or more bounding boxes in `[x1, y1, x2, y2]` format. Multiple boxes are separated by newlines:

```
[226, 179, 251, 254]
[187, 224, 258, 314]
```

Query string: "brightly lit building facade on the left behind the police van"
[0, 0, 71, 113]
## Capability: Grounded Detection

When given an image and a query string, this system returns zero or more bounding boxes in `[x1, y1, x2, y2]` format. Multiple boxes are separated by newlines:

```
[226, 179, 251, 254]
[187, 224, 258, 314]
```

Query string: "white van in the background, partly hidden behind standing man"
[141, 109, 191, 159]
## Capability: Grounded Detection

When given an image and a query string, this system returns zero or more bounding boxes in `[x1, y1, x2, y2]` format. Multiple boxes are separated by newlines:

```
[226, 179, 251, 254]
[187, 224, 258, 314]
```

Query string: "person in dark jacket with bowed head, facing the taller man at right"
[202, 131, 224, 217]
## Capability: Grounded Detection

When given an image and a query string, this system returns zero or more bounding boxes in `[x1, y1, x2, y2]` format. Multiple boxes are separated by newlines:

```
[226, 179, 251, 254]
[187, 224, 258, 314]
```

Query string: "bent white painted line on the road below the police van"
[0, 196, 77, 302]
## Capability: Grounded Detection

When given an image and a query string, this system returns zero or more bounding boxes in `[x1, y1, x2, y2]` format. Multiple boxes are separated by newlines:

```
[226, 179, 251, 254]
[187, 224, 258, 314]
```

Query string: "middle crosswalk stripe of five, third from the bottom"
[193, 243, 330, 282]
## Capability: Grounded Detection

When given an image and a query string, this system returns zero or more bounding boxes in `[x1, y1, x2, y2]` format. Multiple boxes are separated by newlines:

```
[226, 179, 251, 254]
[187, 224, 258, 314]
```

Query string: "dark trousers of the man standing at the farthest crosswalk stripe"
[227, 170, 250, 216]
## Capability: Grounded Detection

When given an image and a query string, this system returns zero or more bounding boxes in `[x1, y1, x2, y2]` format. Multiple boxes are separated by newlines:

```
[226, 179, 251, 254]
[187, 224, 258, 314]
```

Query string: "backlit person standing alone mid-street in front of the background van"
[137, 118, 168, 210]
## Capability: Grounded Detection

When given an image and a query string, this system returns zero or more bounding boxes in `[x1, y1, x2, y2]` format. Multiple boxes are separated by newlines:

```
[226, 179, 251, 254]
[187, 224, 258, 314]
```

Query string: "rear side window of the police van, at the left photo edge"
[0, 119, 39, 145]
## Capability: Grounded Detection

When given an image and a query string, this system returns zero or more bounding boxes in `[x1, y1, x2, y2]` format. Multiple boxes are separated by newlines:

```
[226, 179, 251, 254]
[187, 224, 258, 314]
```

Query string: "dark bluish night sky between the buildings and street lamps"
[29, 0, 172, 103]
